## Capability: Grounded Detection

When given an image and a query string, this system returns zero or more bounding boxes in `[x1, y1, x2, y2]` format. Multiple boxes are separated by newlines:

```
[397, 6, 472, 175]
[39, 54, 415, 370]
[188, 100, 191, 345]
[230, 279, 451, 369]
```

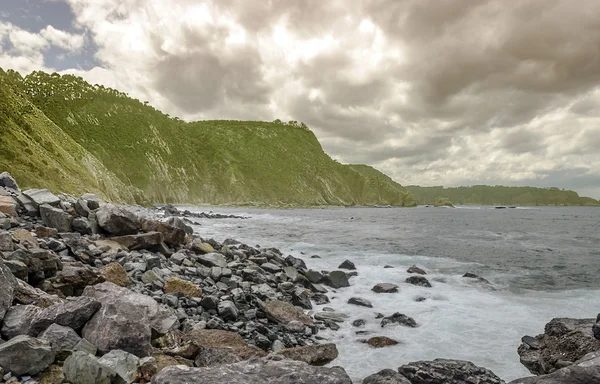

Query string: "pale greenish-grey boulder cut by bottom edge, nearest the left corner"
[63, 351, 117, 384]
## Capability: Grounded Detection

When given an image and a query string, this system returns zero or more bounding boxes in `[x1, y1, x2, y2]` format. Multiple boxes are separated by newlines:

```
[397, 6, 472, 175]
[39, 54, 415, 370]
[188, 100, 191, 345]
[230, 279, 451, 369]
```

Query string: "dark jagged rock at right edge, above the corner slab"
[518, 318, 600, 375]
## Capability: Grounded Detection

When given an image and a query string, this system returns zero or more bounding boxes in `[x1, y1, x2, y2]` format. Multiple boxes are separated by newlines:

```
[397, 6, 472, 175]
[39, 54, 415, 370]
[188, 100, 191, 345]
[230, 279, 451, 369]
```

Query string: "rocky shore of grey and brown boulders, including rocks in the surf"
[0, 172, 600, 384]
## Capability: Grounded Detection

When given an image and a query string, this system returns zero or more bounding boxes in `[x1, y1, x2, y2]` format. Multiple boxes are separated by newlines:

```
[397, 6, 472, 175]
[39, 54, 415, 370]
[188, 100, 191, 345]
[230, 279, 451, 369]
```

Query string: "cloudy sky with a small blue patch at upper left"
[0, 0, 600, 198]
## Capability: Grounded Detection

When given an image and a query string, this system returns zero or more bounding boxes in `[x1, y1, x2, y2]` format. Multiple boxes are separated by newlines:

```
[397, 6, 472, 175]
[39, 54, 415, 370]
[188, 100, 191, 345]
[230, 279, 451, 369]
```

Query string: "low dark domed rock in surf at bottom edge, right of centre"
[398, 359, 504, 384]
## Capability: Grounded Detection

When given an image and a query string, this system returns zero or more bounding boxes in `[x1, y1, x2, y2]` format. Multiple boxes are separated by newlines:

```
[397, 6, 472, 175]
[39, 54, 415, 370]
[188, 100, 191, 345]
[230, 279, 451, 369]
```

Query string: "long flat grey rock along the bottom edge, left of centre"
[152, 359, 352, 384]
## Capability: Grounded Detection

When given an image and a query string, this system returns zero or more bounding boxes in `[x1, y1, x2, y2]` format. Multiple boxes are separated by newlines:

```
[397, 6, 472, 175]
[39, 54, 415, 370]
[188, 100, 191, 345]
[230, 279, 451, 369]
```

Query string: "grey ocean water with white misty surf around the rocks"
[186, 207, 600, 382]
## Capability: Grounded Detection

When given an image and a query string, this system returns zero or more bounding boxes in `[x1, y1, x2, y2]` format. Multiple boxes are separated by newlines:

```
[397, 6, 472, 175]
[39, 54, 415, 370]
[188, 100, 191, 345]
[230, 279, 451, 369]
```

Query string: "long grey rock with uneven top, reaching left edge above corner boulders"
[2, 297, 100, 339]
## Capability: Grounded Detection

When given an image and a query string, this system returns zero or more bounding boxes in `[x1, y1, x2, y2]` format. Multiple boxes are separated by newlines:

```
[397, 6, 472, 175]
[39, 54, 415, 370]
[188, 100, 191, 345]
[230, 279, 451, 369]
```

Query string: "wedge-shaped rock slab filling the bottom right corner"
[509, 351, 600, 384]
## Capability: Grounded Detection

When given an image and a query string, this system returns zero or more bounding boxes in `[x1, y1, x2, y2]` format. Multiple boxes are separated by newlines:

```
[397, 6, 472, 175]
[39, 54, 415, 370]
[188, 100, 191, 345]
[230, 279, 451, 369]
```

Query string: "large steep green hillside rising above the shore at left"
[0, 70, 414, 206]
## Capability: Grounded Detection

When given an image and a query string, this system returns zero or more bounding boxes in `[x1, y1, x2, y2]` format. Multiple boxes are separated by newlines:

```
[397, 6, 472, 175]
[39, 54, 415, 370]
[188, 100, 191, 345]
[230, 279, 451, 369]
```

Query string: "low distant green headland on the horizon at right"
[407, 185, 600, 206]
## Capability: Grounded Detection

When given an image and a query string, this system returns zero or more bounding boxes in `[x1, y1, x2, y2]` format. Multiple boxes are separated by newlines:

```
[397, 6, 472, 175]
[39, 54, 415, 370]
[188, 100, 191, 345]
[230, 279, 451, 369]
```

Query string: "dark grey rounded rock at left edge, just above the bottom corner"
[0, 335, 55, 376]
